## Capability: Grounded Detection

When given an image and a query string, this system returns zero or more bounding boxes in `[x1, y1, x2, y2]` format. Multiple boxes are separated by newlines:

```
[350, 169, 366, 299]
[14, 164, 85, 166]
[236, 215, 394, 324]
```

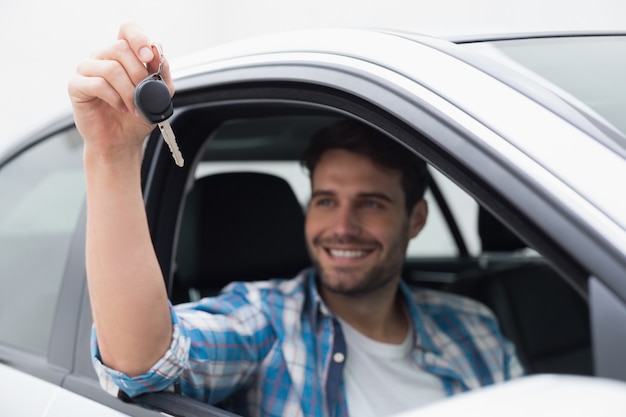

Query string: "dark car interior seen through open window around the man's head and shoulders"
[160, 114, 593, 382]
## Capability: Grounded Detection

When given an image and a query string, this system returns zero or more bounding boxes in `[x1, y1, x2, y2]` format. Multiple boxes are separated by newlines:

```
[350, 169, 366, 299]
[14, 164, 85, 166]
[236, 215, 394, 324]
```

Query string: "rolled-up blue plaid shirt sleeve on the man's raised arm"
[92, 284, 277, 403]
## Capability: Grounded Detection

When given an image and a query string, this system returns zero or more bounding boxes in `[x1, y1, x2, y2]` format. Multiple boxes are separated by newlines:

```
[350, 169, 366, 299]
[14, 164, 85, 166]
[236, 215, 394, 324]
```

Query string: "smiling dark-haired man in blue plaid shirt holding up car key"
[68, 24, 521, 416]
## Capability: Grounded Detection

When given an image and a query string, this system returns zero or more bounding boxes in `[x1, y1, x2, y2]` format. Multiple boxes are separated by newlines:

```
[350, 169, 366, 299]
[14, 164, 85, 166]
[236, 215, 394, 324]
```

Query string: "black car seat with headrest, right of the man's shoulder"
[448, 208, 593, 375]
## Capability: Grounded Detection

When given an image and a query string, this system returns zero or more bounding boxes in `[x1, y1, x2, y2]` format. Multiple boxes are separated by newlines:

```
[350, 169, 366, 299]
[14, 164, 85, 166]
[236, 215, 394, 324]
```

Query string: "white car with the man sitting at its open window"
[0, 29, 626, 416]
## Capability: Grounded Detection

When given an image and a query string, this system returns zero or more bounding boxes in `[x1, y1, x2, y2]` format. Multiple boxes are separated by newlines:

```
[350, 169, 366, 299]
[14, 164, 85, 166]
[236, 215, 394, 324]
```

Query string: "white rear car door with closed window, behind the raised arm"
[0, 121, 176, 417]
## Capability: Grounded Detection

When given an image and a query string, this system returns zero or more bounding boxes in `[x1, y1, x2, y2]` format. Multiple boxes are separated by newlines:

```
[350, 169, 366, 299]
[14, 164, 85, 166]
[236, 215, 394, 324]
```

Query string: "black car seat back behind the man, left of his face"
[177, 172, 309, 289]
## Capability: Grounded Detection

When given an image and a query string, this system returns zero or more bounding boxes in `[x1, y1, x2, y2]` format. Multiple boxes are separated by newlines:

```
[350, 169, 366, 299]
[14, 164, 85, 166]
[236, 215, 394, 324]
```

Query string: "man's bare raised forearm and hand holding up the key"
[68, 24, 174, 376]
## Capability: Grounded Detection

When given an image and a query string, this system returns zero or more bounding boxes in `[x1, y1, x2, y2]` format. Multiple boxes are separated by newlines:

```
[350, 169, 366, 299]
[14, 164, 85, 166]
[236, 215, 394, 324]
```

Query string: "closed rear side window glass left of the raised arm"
[0, 129, 85, 354]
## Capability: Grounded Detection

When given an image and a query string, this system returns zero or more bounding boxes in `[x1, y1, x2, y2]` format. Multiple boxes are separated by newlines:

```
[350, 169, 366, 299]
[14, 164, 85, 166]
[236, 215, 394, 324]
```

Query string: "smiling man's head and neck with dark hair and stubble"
[304, 121, 428, 342]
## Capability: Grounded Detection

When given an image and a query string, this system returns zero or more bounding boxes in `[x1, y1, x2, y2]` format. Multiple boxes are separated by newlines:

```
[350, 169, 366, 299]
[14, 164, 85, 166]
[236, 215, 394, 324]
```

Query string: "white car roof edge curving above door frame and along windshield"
[172, 29, 626, 148]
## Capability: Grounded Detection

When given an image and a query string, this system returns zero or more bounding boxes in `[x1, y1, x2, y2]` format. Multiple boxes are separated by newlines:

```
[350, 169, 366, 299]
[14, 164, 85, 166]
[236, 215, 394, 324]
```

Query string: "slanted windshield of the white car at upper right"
[467, 36, 626, 136]
